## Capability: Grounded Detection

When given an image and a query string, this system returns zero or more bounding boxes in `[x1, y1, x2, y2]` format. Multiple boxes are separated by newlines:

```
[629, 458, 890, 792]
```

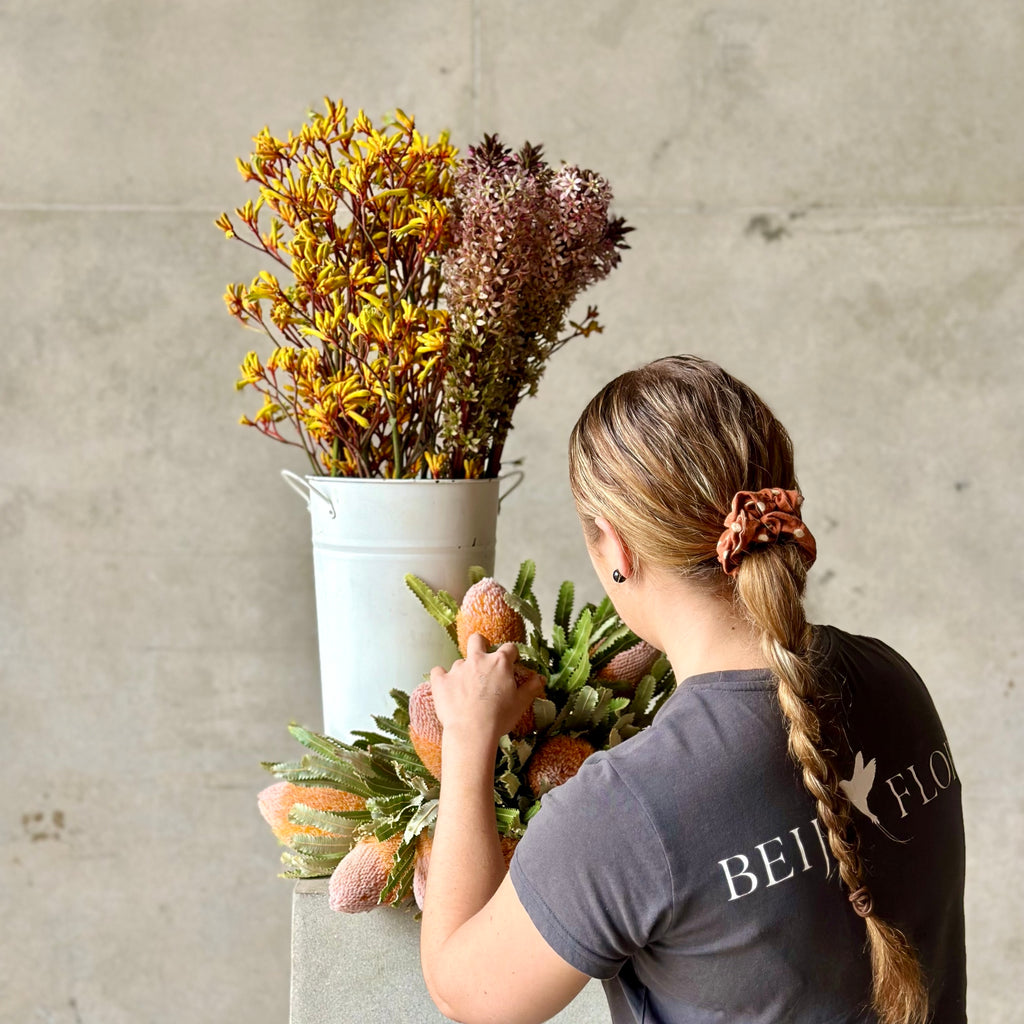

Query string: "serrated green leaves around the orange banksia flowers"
[263, 560, 675, 902]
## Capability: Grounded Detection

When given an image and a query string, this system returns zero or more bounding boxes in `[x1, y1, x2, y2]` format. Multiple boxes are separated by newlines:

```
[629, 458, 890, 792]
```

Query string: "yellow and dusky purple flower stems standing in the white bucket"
[216, 100, 631, 479]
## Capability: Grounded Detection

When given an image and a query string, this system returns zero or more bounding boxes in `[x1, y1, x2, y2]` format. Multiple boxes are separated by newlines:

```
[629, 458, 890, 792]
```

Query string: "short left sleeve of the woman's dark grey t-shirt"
[509, 754, 673, 978]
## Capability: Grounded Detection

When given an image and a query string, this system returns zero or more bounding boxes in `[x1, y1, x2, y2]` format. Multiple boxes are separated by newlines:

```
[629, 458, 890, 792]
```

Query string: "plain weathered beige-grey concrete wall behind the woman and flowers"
[0, 0, 1024, 1024]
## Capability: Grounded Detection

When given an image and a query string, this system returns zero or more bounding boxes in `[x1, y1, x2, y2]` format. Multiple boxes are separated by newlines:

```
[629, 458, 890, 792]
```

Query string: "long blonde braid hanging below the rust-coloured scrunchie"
[735, 545, 928, 1024]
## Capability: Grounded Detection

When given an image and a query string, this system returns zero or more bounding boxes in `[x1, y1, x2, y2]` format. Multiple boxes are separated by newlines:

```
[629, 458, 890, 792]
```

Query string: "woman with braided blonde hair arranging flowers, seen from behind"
[421, 356, 966, 1024]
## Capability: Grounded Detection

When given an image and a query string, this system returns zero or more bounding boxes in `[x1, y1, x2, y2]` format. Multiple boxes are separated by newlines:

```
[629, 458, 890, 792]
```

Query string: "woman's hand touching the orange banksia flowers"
[430, 633, 544, 746]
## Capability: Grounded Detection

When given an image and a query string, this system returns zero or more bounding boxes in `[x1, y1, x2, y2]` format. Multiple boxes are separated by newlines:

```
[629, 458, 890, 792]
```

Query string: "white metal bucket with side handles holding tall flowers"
[282, 470, 521, 740]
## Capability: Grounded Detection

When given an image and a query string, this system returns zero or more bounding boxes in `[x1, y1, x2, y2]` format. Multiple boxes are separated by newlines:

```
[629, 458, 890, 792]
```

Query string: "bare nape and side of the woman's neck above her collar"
[641, 575, 768, 682]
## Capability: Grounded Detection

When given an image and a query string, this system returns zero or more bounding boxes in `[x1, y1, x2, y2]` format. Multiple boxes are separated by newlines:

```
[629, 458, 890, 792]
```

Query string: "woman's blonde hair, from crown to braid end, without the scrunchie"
[569, 355, 928, 1024]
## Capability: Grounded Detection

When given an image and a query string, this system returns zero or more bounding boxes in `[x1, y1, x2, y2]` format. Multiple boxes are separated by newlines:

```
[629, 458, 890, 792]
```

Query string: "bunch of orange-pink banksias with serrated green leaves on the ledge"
[259, 560, 675, 912]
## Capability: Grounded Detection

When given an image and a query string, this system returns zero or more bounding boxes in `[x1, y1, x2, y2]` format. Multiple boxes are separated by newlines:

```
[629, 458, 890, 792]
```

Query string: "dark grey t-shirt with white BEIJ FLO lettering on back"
[511, 627, 967, 1024]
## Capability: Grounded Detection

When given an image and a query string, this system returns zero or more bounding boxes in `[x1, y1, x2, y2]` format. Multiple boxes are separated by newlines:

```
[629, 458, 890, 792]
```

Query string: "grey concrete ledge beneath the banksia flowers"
[289, 879, 611, 1024]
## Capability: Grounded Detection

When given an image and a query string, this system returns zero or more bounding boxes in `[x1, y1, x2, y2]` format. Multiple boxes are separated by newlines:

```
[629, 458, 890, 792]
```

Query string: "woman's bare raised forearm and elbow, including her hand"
[420, 635, 589, 1024]
